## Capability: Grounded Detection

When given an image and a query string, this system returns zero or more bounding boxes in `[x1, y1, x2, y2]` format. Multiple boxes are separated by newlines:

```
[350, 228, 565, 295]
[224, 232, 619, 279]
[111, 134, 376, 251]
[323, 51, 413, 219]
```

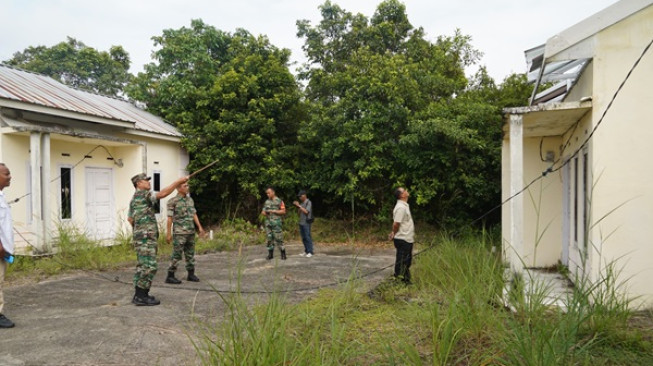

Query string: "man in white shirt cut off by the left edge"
[0, 163, 14, 328]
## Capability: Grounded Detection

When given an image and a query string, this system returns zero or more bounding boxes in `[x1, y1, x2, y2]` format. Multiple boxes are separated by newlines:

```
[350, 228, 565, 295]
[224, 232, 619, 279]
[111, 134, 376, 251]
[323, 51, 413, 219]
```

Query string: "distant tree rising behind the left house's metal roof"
[4, 37, 131, 96]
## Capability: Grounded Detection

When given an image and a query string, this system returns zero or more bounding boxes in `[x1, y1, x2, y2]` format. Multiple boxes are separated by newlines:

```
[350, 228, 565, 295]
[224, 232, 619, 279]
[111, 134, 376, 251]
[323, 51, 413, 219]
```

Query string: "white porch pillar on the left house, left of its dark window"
[29, 132, 45, 253]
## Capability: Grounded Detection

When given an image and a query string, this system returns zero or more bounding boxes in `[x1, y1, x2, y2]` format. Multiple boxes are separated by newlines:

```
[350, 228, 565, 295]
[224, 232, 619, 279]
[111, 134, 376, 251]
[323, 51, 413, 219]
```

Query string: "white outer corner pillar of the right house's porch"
[508, 114, 524, 273]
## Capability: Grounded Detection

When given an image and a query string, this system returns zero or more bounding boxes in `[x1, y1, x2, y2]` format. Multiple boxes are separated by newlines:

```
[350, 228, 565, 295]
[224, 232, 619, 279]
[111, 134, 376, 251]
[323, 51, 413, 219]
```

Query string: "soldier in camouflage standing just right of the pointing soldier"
[166, 183, 204, 284]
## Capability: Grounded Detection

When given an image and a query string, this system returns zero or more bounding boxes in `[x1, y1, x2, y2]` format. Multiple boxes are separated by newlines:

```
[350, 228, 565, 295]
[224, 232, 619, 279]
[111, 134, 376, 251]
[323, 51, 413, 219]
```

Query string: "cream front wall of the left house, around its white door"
[0, 130, 182, 251]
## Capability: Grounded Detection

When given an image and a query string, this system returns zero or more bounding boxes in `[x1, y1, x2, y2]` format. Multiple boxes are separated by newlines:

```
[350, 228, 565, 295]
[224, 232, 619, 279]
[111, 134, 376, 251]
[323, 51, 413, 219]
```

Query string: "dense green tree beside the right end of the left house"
[127, 20, 305, 219]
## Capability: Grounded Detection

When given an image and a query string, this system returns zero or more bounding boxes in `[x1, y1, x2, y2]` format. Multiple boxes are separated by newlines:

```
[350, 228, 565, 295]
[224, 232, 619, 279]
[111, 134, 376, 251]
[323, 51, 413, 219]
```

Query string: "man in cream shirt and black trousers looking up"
[389, 187, 415, 285]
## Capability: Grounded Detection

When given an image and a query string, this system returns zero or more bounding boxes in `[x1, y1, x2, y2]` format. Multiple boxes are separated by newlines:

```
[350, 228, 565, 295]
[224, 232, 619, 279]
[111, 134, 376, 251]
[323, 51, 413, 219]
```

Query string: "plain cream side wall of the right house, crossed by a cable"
[591, 7, 653, 306]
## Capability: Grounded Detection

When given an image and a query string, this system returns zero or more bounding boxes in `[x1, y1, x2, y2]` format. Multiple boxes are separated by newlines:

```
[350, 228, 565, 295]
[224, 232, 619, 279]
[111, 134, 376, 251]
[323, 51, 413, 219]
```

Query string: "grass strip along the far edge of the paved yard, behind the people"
[7, 215, 418, 280]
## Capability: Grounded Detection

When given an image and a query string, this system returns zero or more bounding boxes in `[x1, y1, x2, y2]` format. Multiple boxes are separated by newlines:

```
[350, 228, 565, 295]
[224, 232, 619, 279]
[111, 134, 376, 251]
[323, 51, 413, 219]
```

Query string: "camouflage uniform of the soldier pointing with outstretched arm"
[128, 189, 159, 290]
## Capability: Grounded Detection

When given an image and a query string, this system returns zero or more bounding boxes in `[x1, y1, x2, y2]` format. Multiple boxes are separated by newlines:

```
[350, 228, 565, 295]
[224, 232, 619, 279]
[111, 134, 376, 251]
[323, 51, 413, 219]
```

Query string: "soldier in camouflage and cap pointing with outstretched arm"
[127, 173, 188, 306]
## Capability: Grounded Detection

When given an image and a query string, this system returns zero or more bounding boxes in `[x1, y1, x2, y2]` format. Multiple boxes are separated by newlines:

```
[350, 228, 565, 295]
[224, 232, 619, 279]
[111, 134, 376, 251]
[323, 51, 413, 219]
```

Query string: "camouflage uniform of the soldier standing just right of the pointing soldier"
[168, 194, 197, 272]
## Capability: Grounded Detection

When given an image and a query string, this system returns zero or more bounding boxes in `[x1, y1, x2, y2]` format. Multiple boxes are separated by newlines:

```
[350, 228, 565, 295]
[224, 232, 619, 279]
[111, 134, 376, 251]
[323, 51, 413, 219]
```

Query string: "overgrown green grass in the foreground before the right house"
[195, 236, 653, 365]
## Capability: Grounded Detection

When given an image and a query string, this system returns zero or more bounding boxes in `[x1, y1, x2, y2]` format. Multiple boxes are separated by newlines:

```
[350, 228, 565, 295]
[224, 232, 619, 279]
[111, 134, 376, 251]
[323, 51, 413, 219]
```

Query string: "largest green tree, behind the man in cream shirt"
[297, 0, 526, 224]
